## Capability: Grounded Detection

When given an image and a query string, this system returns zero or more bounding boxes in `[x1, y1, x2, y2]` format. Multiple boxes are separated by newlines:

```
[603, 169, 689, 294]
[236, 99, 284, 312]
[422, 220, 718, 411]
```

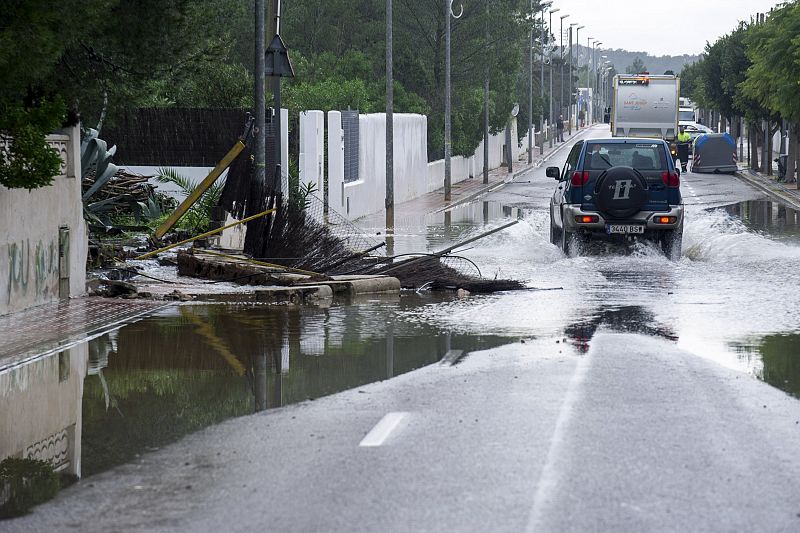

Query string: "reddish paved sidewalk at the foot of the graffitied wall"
[0, 297, 169, 372]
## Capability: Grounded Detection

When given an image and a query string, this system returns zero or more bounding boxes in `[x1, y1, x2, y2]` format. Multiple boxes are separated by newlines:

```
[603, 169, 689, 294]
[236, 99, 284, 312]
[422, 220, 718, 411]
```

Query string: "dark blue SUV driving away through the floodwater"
[547, 137, 683, 259]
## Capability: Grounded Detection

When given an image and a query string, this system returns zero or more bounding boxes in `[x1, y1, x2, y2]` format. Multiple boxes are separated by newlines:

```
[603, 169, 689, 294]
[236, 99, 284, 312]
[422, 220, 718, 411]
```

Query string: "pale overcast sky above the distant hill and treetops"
[545, 0, 778, 56]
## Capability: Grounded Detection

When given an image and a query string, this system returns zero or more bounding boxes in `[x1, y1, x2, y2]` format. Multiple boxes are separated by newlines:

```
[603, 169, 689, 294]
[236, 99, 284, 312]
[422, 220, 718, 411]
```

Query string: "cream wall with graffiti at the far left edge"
[0, 126, 89, 315]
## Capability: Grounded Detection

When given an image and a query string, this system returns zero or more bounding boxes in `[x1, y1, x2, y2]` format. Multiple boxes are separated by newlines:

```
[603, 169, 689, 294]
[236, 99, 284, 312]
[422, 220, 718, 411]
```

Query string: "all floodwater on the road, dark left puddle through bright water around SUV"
[0, 129, 800, 494]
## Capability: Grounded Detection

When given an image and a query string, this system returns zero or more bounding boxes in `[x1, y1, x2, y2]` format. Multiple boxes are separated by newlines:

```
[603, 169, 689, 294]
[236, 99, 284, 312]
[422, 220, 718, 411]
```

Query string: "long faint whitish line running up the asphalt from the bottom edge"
[526, 350, 592, 533]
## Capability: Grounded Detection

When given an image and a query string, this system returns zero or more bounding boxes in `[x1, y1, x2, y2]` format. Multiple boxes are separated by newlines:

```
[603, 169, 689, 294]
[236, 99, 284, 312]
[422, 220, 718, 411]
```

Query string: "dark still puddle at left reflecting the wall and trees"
[0, 296, 511, 477]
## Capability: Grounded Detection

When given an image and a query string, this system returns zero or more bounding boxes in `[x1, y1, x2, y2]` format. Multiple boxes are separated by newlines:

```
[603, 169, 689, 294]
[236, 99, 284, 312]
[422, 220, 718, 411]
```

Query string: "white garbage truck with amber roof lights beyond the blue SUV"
[611, 72, 680, 142]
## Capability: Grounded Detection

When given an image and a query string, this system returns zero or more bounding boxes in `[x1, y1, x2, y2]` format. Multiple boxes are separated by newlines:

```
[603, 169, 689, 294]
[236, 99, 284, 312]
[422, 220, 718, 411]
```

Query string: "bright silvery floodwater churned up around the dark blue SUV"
[408, 196, 800, 395]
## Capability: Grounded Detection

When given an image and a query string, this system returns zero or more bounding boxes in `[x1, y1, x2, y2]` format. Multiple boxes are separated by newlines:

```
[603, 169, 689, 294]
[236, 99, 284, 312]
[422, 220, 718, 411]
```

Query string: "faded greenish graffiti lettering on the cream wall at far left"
[0, 239, 59, 305]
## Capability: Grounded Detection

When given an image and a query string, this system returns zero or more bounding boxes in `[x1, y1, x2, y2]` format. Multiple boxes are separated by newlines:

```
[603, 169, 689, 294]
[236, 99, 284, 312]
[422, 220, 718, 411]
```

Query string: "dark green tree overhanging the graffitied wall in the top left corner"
[0, 0, 237, 189]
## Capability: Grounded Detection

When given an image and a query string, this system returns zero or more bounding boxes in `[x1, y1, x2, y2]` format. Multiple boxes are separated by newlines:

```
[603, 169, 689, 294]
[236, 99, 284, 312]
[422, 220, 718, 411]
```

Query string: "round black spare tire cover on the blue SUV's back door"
[594, 166, 647, 218]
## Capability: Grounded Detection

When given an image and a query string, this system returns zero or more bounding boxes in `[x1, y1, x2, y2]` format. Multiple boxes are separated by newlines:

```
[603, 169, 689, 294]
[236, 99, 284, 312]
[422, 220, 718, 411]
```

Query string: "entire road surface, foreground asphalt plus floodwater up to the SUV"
[0, 128, 800, 531]
